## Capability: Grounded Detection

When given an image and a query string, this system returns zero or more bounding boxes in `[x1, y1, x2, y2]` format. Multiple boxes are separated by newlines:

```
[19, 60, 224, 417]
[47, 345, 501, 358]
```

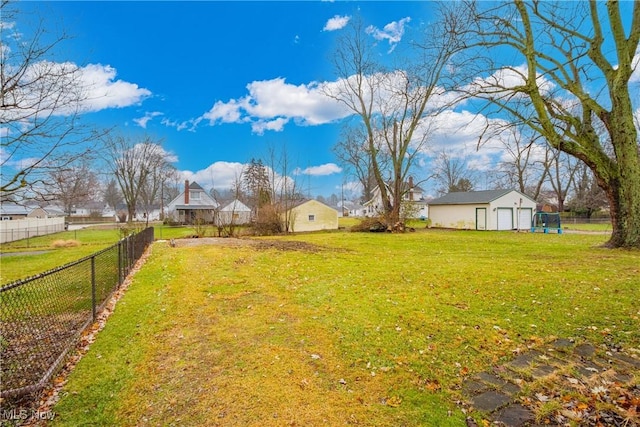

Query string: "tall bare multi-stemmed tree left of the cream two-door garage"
[325, 14, 460, 227]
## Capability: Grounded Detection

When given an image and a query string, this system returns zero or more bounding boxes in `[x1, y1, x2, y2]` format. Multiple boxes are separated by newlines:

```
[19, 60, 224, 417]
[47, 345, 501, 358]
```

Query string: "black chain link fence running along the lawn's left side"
[0, 228, 154, 399]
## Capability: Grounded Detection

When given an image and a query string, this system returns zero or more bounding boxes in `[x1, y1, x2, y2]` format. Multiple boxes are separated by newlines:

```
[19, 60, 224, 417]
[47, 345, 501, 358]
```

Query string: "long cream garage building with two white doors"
[429, 190, 536, 230]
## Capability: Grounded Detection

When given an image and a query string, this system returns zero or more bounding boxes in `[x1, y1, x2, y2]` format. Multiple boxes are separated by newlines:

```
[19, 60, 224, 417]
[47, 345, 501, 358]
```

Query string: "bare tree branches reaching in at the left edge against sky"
[0, 0, 101, 201]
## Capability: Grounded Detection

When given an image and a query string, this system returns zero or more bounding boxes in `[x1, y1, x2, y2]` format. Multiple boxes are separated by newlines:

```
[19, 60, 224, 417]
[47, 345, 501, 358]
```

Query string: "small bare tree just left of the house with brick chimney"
[103, 135, 167, 222]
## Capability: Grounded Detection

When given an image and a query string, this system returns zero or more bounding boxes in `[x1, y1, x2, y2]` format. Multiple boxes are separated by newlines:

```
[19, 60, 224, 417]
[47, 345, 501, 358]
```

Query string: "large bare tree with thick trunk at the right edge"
[455, 0, 640, 248]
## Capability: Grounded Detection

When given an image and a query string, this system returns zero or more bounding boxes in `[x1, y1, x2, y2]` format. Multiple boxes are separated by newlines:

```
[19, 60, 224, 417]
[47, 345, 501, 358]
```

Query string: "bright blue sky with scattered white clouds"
[8, 1, 640, 201]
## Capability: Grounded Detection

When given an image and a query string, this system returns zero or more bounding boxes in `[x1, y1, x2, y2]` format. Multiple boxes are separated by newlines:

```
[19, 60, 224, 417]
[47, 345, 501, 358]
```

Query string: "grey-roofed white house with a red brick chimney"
[167, 180, 218, 224]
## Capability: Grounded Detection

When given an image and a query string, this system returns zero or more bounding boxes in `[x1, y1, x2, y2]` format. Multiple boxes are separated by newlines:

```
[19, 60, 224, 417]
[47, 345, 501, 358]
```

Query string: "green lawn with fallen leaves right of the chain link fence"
[47, 230, 640, 426]
